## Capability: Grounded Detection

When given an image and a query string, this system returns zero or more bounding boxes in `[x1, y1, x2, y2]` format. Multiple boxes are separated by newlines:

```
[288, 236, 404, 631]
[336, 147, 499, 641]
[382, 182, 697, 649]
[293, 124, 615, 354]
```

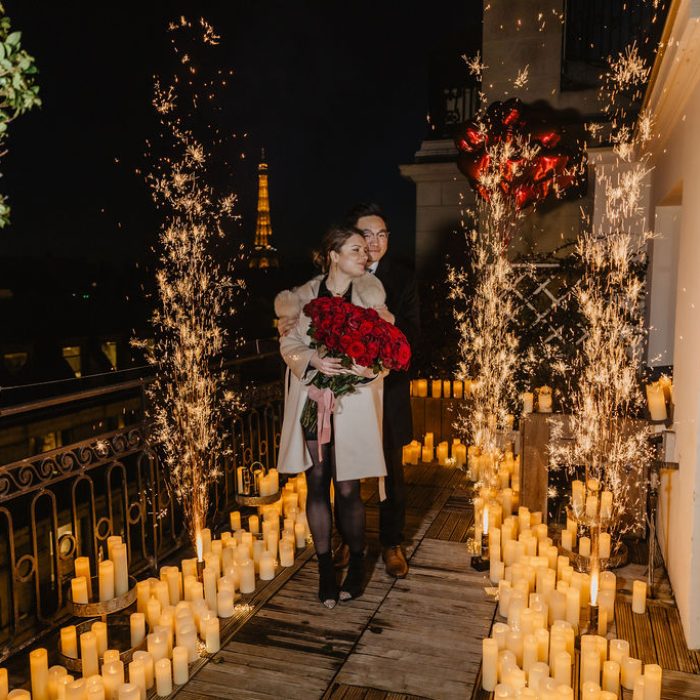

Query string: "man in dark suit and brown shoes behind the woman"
[336, 203, 420, 578]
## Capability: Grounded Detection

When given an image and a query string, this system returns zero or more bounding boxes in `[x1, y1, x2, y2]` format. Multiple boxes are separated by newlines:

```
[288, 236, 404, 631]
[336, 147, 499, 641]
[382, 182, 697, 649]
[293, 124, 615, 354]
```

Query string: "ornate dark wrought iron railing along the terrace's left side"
[0, 355, 283, 660]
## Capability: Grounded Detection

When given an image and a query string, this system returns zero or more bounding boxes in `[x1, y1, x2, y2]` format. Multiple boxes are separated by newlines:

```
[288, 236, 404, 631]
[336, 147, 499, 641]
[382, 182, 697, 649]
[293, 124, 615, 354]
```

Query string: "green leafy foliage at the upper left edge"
[0, 2, 41, 228]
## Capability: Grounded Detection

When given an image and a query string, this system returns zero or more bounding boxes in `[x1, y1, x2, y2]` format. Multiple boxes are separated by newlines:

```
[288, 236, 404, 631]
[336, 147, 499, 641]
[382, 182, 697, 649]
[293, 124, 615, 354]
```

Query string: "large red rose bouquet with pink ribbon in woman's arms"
[301, 297, 411, 449]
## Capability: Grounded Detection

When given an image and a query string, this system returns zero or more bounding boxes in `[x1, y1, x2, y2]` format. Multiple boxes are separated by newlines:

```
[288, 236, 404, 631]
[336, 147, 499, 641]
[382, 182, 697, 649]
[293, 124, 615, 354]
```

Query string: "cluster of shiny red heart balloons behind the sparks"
[455, 99, 581, 210]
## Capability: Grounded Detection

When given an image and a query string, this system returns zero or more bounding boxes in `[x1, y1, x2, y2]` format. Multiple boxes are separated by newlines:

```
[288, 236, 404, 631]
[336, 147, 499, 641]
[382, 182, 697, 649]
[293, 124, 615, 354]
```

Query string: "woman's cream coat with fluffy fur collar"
[275, 273, 386, 481]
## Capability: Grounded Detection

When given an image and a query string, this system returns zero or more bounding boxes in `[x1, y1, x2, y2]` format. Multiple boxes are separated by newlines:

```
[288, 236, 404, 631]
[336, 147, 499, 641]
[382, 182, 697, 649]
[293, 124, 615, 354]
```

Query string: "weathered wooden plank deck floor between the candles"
[173, 465, 700, 700]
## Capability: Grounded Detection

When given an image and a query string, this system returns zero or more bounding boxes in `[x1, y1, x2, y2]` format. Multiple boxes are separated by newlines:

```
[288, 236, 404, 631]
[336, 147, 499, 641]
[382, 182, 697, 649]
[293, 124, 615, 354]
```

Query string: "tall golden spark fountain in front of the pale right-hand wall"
[550, 45, 652, 536]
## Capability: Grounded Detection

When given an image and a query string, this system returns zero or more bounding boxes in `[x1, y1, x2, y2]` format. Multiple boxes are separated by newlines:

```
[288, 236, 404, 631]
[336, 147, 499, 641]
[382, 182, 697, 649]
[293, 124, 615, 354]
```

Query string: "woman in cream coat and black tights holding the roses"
[275, 228, 386, 608]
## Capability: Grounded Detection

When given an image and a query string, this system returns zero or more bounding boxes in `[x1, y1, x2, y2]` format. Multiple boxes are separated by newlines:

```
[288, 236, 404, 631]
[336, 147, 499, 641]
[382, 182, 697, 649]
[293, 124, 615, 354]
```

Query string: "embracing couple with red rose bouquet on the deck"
[275, 204, 419, 608]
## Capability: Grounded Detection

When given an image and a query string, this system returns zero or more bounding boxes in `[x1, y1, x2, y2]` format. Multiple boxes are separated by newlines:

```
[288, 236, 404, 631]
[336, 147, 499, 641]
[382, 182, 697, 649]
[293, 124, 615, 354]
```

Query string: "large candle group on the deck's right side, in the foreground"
[482, 505, 661, 700]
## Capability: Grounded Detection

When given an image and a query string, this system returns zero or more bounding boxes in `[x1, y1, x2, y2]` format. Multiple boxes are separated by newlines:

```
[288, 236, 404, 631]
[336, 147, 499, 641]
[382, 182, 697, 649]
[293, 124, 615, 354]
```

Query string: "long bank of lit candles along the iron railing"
[0, 475, 309, 700]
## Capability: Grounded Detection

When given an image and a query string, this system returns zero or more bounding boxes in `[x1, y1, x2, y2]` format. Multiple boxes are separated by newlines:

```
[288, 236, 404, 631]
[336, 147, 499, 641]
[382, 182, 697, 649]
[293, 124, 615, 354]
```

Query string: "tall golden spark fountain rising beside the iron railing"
[135, 17, 242, 541]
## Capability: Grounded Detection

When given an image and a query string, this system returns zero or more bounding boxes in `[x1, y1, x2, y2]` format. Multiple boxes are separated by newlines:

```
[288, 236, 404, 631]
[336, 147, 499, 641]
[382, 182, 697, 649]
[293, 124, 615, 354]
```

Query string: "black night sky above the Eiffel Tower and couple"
[0, 0, 481, 270]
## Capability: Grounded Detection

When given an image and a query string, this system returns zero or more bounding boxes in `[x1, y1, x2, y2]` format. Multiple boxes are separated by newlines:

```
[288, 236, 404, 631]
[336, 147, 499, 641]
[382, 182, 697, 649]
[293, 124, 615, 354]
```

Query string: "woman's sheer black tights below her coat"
[306, 440, 365, 554]
